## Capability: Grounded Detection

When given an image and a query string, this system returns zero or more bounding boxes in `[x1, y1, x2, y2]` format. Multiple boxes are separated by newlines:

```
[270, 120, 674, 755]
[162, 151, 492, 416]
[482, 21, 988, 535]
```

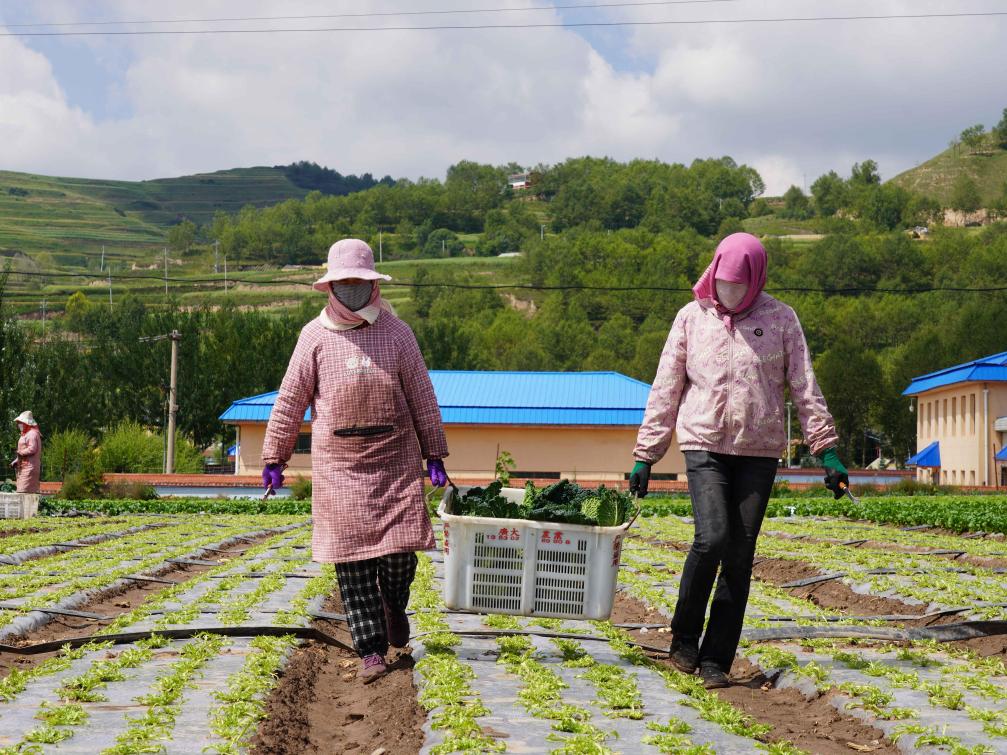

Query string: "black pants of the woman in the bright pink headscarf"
[672, 451, 776, 671]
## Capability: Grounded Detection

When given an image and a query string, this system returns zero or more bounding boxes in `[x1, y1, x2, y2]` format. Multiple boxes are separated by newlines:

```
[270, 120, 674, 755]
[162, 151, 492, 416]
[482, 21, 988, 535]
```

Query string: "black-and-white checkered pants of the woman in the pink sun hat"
[335, 553, 419, 658]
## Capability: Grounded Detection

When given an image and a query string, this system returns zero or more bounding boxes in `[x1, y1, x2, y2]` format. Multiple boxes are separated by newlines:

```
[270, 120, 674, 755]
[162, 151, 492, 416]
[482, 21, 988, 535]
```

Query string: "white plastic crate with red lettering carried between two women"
[438, 487, 632, 619]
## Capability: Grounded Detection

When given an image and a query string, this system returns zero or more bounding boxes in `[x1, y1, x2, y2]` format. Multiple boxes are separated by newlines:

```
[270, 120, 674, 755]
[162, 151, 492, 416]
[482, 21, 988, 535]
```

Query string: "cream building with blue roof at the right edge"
[902, 351, 1007, 485]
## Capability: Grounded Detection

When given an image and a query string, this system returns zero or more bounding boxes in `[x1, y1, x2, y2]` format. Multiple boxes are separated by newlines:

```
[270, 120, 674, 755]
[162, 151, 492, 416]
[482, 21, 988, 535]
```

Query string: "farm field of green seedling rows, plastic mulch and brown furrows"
[0, 497, 1007, 755]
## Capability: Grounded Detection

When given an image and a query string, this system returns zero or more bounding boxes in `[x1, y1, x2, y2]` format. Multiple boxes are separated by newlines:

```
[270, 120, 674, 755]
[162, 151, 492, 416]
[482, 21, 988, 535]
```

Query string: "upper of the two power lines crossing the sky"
[4, 0, 747, 29]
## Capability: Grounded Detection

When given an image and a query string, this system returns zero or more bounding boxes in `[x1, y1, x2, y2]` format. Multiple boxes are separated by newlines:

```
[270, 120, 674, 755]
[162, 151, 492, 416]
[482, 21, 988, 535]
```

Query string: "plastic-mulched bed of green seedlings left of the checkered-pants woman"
[0, 533, 335, 755]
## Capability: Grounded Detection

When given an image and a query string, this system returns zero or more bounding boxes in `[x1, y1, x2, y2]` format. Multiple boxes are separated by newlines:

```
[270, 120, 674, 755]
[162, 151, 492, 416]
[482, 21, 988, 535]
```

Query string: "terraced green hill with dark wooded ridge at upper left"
[0, 167, 328, 268]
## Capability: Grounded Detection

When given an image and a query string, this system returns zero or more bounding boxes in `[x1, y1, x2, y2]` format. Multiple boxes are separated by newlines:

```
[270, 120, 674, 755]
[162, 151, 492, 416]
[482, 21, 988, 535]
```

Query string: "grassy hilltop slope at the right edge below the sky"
[891, 142, 1007, 205]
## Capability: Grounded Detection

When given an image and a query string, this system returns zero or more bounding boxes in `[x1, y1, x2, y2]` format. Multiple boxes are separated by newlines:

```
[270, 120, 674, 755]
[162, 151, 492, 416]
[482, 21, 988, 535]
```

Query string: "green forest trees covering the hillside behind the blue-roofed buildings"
[0, 147, 1007, 479]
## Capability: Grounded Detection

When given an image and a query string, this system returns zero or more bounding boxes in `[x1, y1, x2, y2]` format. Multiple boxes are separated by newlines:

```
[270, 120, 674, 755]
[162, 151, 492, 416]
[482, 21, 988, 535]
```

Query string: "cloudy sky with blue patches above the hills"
[0, 0, 1007, 194]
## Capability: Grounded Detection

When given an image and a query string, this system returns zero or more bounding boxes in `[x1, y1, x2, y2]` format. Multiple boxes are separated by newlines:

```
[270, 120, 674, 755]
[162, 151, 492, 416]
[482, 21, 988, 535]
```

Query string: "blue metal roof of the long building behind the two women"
[221, 369, 651, 426]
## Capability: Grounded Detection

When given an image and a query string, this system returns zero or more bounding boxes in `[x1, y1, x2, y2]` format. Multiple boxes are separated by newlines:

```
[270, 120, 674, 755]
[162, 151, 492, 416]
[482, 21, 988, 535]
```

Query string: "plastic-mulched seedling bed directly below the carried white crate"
[412, 556, 800, 755]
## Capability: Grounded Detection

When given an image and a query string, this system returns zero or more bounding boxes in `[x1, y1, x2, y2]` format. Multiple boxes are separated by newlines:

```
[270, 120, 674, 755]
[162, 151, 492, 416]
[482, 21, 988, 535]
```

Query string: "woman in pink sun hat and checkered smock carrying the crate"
[262, 239, 447, 684]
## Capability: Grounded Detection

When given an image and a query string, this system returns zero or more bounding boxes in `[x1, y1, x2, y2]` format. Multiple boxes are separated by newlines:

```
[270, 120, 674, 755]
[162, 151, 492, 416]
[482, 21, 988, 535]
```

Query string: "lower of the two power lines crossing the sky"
[0, 11, 1007, 37]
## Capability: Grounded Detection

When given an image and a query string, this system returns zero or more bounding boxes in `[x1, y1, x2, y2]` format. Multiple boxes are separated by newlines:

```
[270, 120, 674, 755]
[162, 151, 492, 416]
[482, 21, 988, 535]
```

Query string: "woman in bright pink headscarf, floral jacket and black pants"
[629, 234, 849, 689]
